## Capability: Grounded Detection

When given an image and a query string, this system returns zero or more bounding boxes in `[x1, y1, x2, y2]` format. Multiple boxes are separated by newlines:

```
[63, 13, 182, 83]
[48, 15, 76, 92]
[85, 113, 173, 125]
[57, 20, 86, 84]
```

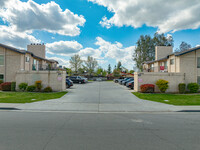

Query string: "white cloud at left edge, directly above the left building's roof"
[0, 25, 41, 49]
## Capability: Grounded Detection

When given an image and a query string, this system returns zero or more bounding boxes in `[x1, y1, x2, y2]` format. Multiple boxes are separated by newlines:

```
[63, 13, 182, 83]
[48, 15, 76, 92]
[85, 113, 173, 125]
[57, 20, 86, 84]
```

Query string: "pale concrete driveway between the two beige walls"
[18, 82, 178, 112]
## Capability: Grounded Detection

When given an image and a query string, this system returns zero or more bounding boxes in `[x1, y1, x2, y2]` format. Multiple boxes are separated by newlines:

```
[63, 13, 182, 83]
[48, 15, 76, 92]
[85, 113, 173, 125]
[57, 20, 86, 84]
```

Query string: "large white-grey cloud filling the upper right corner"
[88, 0, 200, 33]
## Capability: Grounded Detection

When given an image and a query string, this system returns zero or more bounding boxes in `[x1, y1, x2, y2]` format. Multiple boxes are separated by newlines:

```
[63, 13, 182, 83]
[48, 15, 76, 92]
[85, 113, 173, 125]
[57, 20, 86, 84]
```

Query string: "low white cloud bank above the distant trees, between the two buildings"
[46, 37, 135, 69]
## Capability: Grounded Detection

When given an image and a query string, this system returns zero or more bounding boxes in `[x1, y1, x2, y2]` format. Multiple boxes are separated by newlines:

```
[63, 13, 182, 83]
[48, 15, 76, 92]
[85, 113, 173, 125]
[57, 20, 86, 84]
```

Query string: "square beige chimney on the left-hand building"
[27, 43, 46, 58]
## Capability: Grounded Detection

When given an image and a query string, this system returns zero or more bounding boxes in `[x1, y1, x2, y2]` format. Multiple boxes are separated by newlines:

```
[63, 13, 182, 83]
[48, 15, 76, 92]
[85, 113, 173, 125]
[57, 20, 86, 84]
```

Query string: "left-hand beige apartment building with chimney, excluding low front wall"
[0, 44, 58, 82]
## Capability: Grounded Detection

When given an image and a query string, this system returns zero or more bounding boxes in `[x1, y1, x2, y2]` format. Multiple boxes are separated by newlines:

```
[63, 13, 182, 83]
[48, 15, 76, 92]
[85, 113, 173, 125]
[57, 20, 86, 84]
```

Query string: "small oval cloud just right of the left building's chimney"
[46, 41, 83, 56]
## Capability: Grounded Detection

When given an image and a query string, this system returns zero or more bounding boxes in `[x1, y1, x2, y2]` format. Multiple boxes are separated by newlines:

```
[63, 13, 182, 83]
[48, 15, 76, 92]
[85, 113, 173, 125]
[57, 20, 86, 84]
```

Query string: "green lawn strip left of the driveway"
[0, 92, 67, 103]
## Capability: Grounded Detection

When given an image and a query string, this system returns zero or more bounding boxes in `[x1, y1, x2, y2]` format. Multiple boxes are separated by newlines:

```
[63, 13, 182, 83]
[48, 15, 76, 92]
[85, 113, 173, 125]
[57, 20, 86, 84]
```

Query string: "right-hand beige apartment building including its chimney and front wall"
[134, 46, 200, 92]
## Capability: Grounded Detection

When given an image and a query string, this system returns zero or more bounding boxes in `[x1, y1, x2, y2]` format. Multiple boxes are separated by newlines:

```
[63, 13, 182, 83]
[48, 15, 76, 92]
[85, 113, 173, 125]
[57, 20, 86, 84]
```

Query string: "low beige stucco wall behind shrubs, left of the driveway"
[16, 71, 66, 91]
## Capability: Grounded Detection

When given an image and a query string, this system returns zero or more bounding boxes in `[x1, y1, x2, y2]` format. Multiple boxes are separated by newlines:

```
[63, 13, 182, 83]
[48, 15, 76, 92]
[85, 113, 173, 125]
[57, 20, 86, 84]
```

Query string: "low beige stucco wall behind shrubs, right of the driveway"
[134, 72, 185, 93]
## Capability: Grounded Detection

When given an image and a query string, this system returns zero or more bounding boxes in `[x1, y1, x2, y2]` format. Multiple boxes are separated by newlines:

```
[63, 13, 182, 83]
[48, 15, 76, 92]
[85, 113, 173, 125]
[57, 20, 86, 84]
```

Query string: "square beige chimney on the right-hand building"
[155, 46, 173, 60]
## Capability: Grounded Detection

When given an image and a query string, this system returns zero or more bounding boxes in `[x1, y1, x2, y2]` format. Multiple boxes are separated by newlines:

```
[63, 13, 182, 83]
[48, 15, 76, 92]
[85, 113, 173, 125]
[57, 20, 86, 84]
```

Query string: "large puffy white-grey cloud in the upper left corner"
[0, 0, 85, 36]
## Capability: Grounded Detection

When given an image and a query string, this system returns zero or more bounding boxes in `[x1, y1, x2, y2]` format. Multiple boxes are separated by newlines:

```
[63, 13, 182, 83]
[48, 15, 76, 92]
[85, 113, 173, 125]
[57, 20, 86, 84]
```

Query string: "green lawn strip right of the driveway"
[133, 93, 200, 105]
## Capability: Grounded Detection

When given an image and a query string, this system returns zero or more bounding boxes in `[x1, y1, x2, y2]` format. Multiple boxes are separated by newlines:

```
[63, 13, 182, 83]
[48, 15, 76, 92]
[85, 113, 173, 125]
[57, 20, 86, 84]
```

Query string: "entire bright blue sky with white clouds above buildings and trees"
[0, 0, 200, 69]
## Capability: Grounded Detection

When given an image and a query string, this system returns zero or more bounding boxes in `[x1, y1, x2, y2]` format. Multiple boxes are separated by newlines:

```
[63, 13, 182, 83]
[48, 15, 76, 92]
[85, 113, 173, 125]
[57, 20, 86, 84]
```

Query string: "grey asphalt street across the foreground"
[0, 111, 200, 150]
